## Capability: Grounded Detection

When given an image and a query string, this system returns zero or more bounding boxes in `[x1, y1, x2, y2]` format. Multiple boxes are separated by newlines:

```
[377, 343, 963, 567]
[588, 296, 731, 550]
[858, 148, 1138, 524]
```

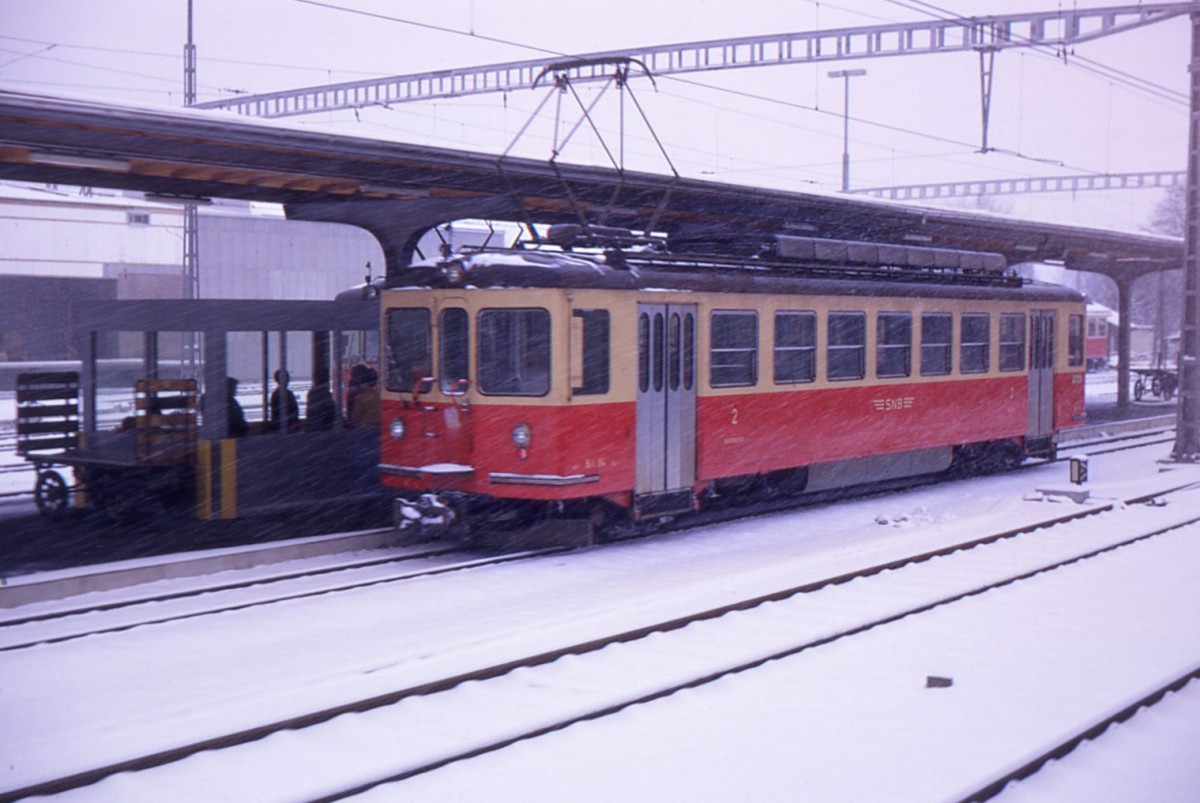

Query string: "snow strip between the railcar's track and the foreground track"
[0, 447, 1200, 799]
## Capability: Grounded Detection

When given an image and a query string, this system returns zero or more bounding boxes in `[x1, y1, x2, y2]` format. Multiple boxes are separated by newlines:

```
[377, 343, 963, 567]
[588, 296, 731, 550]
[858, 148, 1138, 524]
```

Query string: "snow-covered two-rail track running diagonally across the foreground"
[9, 472, 1200, 799]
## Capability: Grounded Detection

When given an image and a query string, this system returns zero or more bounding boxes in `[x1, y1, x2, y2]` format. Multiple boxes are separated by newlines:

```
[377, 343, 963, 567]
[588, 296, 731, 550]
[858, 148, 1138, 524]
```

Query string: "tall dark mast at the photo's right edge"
[1172, 8, 1200, 462]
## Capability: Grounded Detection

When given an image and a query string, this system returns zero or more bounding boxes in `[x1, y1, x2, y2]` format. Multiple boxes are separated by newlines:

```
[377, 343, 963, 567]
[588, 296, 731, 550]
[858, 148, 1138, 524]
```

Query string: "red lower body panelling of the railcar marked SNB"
[380, 373, 1084, 499]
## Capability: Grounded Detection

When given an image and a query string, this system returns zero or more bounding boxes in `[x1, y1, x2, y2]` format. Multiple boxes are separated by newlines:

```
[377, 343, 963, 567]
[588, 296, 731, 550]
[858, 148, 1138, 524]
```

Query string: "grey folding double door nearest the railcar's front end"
[637, 304, 696, 514]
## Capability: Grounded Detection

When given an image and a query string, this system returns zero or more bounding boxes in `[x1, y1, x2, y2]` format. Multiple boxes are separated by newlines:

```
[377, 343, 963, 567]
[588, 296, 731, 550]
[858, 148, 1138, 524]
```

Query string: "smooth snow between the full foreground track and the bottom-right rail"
[369, 520, 1200, 803]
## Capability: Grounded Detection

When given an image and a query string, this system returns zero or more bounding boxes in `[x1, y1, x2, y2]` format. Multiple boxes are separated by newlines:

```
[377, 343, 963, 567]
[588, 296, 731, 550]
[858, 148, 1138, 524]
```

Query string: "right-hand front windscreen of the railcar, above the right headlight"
[478, 310, 550, 396]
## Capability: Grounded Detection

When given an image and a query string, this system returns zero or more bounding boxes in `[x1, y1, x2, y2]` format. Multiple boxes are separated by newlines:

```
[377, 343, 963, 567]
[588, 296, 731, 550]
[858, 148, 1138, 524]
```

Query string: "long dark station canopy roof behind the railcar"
[0, 91, 1183, 275]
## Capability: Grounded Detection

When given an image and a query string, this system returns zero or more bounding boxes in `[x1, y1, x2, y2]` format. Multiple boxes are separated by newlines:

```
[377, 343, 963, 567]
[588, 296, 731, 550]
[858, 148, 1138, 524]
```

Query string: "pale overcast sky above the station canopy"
[0, 0, 1189, 229]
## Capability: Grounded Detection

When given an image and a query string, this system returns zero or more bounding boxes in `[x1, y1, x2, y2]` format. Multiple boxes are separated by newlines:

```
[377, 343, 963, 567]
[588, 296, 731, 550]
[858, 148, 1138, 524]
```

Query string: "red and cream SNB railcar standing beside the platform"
[380, 235, 1084, 542]
